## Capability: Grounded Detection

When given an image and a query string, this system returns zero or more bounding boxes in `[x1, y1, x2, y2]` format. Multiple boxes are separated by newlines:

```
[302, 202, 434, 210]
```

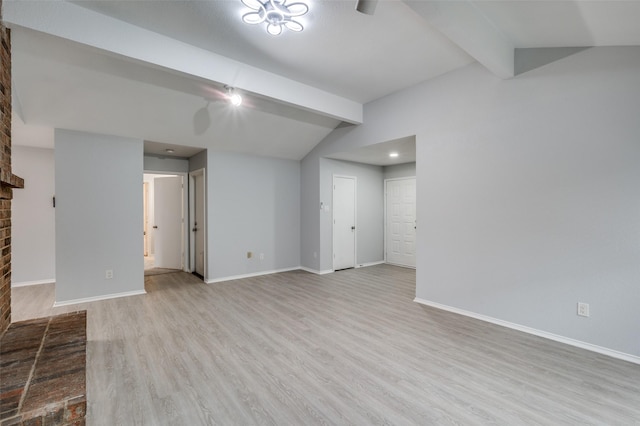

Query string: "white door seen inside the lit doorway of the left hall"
[153, 176, 183, 269]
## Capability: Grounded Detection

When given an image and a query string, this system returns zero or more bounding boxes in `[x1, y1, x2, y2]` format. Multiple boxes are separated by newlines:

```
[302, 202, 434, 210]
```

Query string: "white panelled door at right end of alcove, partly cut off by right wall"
[385, 178, 417, 268]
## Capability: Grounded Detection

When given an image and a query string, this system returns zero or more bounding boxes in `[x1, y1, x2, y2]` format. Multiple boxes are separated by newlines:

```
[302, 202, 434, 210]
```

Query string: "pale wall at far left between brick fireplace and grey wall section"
[11, 145, 56, 285]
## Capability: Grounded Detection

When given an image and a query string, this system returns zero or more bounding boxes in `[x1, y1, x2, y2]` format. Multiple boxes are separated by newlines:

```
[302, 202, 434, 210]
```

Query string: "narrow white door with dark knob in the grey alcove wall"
[333, 176, 356, 271]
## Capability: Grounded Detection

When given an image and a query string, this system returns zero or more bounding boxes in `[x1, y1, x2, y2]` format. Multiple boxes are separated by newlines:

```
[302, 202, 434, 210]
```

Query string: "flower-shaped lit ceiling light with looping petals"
[241, 0, 309, 35]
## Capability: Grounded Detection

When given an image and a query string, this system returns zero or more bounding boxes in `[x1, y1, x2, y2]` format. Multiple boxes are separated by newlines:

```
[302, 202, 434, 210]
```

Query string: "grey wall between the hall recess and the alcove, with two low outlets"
[207, 151, 300, 280]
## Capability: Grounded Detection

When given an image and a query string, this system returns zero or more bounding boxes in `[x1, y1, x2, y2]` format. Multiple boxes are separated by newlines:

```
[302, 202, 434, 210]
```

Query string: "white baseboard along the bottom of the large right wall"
[413, 297, 640, 364]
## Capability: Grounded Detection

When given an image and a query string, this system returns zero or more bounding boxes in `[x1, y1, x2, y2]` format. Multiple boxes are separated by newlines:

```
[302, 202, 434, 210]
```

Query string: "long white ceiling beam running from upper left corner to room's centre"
[3, 1, 363, 124]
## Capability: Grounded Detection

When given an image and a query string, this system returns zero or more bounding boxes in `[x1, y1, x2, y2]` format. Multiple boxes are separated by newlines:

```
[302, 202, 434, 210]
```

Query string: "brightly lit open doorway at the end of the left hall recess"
[143, 172, 187, 275]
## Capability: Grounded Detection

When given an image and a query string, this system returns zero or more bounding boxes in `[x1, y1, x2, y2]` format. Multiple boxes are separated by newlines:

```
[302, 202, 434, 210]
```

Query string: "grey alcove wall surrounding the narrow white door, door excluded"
[318, 158, 384, 271]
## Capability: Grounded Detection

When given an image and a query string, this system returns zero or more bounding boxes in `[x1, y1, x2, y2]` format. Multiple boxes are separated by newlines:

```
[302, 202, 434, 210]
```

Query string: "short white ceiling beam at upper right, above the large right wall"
[404, 0, 515, 79]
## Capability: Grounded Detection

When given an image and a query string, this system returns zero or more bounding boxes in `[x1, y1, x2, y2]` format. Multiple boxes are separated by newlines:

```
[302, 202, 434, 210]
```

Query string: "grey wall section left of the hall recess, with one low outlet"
[55, 129, 144, 303]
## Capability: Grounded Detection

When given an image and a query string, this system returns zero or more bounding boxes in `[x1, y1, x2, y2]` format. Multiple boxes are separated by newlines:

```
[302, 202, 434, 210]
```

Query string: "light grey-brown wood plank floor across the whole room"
[13, 265, 640, 425]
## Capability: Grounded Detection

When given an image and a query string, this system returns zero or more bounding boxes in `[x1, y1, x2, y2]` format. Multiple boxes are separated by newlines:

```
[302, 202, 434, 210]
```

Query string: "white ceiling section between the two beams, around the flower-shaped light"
[70, 0, 473, 103]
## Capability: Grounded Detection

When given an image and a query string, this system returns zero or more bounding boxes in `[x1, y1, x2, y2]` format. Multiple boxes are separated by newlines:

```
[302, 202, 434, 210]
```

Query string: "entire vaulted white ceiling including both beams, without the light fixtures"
[3, 0, 640, 161]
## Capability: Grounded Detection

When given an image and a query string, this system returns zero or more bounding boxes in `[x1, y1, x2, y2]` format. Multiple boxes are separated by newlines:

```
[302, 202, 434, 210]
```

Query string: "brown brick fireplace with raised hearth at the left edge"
[0, 7, 87, 426]
